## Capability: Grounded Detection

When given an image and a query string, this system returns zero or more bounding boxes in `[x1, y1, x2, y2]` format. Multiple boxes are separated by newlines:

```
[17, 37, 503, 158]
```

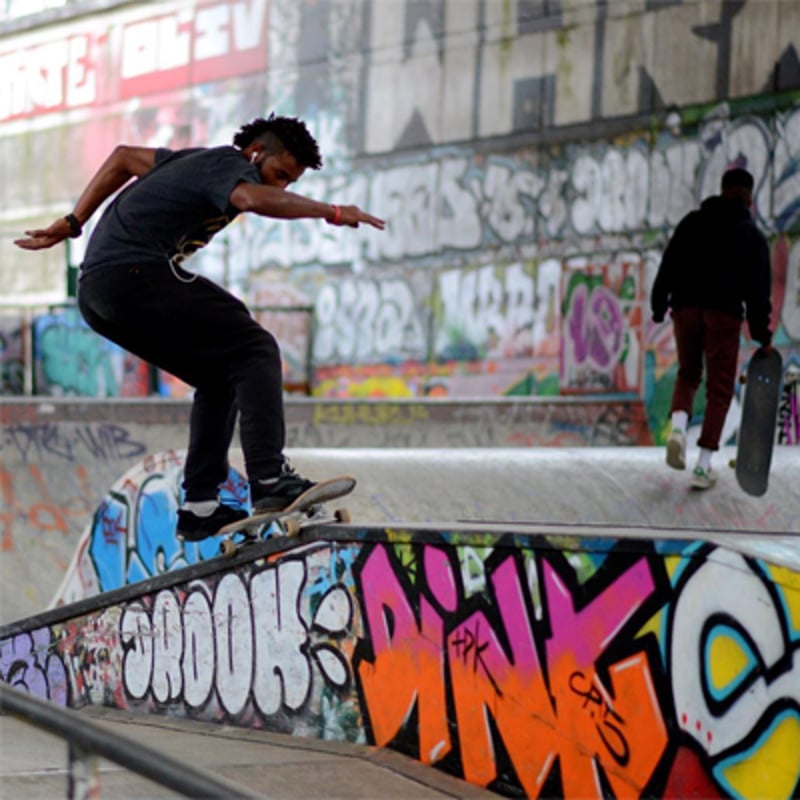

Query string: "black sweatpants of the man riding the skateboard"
[78, 264, 286, 500]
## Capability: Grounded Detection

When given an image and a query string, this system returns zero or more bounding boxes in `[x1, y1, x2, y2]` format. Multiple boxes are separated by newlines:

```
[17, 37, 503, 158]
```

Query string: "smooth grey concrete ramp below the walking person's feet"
[282, 447, 800, 534]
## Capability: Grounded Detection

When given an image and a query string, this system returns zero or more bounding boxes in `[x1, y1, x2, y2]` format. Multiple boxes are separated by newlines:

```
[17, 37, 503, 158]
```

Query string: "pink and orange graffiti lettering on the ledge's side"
[356, 545, 667, 797]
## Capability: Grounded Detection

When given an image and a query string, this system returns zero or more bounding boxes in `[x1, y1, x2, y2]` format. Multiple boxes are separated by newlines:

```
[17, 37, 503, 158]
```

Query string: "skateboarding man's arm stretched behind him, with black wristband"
[14, 144, 156, 250]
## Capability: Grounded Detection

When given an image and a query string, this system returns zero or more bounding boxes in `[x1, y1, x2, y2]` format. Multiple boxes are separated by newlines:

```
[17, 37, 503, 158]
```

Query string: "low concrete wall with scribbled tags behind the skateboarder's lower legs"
[0, 398, 651, 620]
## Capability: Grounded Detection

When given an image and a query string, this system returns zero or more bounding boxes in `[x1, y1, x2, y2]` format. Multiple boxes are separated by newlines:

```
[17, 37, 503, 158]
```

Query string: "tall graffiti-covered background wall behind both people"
[0, 0, 800, 410]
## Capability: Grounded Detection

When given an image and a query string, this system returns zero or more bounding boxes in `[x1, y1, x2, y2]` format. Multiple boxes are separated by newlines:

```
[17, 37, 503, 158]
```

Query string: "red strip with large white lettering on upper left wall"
[0, 0, 268, 121]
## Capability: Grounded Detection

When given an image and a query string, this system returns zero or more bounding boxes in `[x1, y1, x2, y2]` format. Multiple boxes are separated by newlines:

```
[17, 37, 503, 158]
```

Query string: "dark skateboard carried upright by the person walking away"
[735, 347, 783, 497]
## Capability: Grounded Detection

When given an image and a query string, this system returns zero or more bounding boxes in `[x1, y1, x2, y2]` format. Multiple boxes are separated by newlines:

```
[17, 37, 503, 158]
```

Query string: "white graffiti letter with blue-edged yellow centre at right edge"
[669, 549, 800, 757]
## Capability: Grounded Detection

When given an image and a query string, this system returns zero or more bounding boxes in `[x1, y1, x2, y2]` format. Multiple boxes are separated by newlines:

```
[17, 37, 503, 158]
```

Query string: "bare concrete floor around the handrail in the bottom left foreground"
[0, 708, 497, 800]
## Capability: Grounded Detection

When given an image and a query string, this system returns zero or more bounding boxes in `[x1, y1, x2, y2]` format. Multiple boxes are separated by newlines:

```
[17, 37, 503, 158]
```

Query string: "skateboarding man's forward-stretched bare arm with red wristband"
[231, 181, 386, 231]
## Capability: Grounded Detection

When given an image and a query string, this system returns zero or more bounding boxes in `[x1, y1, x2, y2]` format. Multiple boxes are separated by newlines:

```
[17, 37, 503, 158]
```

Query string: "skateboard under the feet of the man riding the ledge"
[214, 475, 356, 556]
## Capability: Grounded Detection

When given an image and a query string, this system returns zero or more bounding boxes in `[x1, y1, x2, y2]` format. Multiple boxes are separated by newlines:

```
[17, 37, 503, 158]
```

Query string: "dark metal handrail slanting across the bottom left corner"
[0, 681, 263, 800]
